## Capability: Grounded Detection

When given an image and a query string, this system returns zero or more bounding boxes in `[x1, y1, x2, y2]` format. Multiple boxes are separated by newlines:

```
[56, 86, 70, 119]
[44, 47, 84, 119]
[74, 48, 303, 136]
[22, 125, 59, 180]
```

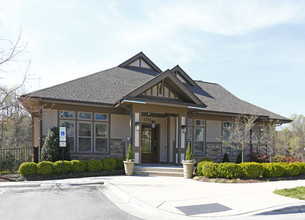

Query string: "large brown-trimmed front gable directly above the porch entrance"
[120, 70, 206, 107]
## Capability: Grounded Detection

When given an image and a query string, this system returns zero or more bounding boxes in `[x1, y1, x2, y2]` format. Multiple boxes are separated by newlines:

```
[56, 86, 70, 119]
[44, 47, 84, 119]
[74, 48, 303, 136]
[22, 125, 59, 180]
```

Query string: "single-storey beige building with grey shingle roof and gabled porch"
[20, 52, 290, 164]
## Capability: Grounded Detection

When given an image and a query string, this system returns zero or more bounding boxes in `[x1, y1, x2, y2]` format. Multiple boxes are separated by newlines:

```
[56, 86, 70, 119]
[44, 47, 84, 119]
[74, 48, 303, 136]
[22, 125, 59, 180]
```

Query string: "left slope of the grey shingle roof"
[27, 67, 159, 104]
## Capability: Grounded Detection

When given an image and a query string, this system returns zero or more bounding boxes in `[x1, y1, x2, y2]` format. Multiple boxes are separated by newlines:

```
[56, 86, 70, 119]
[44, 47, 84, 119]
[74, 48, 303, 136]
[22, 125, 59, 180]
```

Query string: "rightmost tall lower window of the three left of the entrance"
[95, 123, 109, 153]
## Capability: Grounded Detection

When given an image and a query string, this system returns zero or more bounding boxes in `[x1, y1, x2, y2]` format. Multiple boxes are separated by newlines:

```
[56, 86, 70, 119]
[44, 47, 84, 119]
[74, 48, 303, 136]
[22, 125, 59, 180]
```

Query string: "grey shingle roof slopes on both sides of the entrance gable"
[24, 53, 289, 121]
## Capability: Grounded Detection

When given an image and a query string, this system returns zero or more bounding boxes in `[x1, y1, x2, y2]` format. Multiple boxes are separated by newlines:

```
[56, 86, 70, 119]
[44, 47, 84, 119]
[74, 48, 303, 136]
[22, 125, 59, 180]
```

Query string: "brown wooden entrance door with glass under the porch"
[141, 125, 159, 163]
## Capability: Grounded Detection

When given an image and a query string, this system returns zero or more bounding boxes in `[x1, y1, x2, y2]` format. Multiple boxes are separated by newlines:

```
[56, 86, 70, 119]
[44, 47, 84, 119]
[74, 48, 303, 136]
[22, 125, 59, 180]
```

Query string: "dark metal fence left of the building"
[0, 147, 33, 172]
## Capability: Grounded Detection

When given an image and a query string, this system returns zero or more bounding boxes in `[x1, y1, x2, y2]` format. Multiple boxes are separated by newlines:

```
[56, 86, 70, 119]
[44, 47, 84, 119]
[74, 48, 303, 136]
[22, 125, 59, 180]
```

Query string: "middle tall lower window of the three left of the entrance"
[78, 122, 92, 152]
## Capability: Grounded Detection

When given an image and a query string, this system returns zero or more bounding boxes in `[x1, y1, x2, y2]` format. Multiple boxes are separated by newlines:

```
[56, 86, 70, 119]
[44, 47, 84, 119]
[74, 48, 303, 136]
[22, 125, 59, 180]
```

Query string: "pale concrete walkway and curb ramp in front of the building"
[0, 176, 305, 219]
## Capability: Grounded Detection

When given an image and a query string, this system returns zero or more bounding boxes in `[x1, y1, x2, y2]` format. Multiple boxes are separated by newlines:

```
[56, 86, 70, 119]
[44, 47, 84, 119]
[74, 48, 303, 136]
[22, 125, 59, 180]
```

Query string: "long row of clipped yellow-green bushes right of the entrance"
[196, 161, 305, 179]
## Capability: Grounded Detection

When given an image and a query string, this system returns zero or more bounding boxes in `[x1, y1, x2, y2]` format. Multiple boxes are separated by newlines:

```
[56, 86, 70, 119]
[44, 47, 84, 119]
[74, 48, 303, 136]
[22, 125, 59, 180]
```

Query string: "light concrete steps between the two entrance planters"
[134, 166, 183, 177]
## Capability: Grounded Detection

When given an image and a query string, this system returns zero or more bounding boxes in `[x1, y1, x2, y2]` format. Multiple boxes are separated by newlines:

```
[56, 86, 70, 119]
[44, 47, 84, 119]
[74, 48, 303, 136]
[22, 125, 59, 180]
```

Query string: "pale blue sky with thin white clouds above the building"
[0, 0, 305, 117]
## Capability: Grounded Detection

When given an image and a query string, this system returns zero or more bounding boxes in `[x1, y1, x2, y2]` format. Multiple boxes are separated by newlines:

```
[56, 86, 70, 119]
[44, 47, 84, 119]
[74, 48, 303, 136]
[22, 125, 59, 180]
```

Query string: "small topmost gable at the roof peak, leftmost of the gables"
[118, 52, 162, 73]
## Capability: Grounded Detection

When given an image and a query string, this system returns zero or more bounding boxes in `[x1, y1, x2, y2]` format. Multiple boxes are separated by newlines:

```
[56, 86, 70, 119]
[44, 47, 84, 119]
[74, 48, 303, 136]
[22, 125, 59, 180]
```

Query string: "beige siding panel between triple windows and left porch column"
[110, 114, 130, 139]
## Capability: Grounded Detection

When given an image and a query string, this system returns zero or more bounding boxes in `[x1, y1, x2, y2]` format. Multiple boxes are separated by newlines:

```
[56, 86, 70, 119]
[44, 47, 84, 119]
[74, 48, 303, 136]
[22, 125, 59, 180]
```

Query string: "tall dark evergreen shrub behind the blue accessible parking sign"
[41, 127, 70, 162]
